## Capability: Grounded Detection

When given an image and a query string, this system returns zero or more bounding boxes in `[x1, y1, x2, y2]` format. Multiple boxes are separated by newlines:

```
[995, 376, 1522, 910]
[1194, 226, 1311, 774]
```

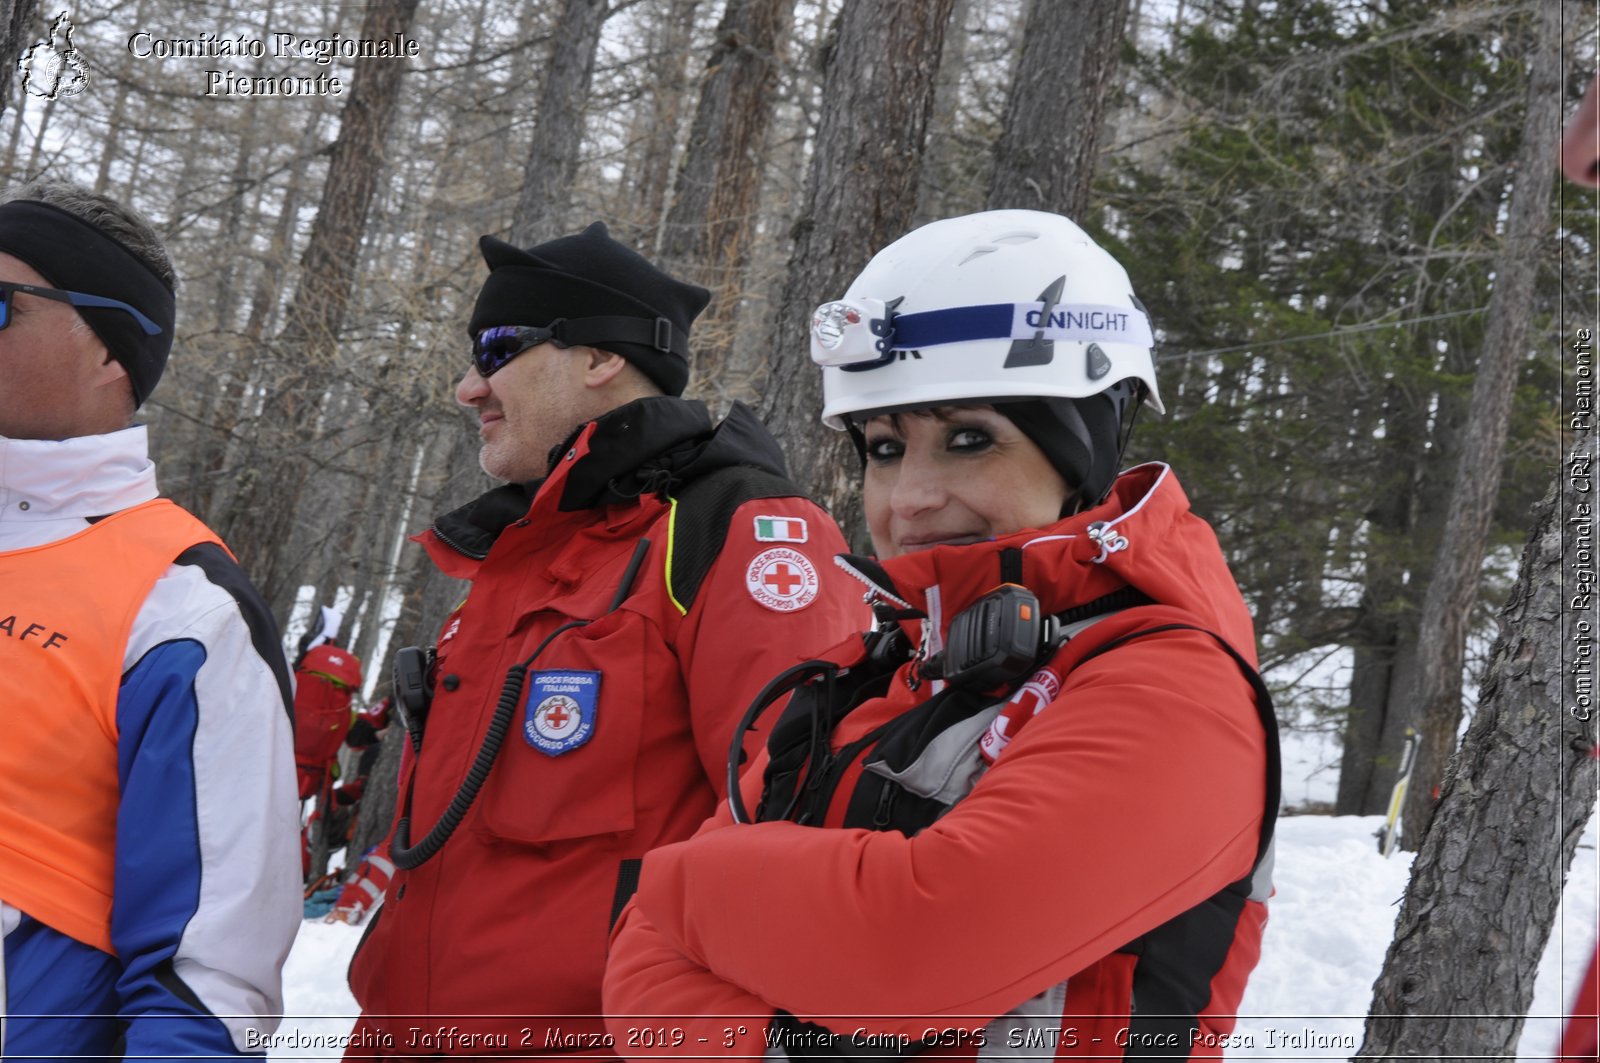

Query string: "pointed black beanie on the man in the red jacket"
[467, 221, 710, 395]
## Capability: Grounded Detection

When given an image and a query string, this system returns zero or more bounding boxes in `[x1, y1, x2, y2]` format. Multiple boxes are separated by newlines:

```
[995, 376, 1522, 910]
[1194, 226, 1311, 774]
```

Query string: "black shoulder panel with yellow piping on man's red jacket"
[666, 466, 806, 613]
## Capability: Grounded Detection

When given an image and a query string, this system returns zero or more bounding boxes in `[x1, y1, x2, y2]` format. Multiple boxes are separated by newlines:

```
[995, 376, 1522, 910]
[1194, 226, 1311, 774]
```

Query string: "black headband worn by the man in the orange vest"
[0, 200, 178, 405]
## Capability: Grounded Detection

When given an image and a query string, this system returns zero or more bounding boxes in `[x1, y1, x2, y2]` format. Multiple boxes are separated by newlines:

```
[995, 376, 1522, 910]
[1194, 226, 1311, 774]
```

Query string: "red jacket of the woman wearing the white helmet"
[605, 466, 1277, 1058]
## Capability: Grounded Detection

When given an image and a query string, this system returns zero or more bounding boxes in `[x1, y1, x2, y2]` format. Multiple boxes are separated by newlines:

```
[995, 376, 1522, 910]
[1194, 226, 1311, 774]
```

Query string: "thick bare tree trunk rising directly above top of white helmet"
[989, 0, 1128, 219]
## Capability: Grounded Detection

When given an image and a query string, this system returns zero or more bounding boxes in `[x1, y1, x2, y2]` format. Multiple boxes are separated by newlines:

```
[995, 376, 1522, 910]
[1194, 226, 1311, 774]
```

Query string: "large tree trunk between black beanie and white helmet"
[762, 0, 952, 541]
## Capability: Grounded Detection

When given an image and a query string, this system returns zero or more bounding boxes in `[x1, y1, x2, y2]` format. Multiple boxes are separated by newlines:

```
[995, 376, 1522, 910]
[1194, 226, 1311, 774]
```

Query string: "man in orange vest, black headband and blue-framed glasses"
[0, 183, 299, 1060]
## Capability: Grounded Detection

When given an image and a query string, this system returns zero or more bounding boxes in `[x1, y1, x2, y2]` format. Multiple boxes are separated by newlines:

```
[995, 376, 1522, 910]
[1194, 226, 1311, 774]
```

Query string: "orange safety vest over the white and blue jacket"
[0, 498, 221, 953]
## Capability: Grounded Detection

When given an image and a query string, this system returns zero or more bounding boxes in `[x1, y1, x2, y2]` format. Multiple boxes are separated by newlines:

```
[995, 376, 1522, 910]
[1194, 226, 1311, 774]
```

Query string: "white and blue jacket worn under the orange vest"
[0, 427, 301, 1063]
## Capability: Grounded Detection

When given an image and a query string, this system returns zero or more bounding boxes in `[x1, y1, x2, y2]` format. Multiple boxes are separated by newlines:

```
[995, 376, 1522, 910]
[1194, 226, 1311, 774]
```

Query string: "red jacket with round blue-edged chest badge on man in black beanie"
[350, 399, 866, 1057]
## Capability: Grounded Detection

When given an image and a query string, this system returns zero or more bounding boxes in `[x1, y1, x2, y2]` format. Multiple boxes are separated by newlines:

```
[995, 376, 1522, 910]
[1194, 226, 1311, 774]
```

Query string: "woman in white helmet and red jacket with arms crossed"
[605, 211, 1278, 1058]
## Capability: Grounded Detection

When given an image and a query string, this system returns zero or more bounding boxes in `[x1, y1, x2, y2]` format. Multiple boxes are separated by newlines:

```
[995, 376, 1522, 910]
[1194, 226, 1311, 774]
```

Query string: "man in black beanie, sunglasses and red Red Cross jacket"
[350, 223, 869, 1058]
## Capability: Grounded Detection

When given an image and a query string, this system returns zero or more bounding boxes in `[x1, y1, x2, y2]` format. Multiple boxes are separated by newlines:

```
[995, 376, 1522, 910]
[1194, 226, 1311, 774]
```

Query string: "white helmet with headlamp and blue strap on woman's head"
[811, 210, 1162, 429]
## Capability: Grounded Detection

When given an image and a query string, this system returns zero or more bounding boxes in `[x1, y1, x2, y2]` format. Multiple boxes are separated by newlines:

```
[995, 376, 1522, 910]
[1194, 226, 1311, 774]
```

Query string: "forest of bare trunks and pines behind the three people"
[0, 0, 1600, 1050]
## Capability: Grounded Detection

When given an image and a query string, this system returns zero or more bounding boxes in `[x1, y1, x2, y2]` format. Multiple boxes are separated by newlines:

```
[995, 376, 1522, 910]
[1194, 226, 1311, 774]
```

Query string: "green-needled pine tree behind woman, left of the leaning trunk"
[1104, 0, 1555, 813]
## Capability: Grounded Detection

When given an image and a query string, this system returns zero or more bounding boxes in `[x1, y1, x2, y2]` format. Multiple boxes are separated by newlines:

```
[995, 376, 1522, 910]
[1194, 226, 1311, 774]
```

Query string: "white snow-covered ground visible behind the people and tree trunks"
[270, 806, 1600, 1060]
